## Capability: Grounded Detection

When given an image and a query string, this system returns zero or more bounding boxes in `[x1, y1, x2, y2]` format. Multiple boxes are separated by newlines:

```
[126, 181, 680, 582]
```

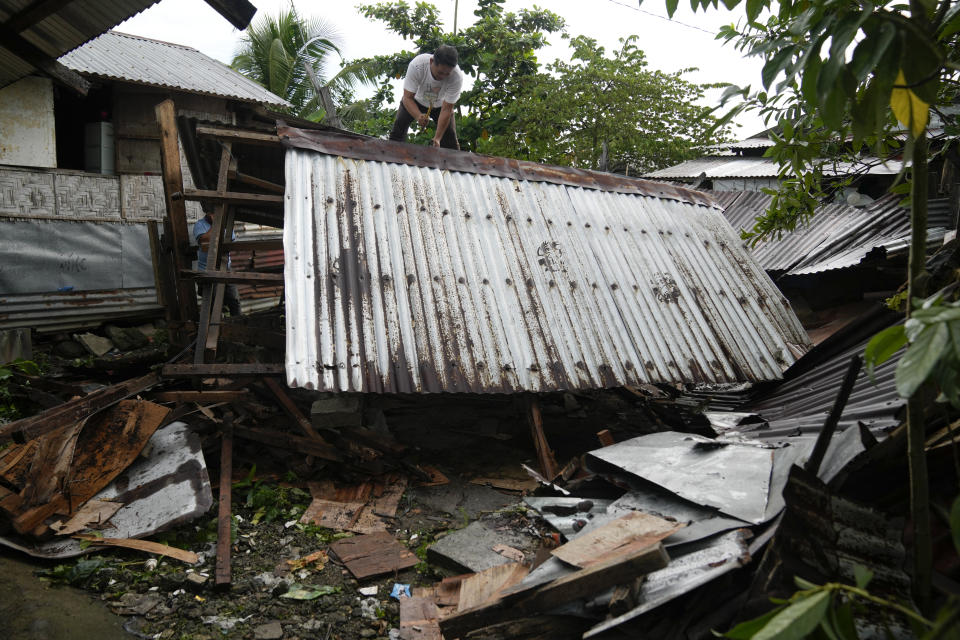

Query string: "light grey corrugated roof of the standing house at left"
[60, 31, 290, 106]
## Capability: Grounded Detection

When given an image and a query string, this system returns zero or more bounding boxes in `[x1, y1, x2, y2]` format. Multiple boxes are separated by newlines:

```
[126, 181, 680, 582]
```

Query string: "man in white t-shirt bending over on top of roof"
[390, 44, 463, 149]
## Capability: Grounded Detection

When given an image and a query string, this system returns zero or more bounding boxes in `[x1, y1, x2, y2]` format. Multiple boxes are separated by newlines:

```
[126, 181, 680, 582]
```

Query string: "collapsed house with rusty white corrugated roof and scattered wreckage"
[0, 69, 956, 638]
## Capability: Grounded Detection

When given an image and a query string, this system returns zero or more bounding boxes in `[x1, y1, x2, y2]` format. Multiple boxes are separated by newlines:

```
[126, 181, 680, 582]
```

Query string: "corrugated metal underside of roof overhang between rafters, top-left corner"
[0, 0, 157, 87]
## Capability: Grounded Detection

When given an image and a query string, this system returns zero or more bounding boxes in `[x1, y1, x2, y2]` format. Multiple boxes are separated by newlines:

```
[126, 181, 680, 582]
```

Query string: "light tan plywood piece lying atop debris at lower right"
[550, 511, 683, 569]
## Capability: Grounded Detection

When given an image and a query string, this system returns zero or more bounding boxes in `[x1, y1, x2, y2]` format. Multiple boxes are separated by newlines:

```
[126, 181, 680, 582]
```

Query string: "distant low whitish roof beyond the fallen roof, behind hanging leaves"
[644, 156, 902, 180]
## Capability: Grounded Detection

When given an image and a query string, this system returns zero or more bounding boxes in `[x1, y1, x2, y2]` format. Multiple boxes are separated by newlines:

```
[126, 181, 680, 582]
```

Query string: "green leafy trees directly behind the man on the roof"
[348, 0, 723, 173]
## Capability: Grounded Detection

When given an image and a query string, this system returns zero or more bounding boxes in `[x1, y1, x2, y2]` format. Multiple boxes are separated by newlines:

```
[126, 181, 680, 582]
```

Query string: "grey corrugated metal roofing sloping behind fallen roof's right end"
[712, 191, 945, 275]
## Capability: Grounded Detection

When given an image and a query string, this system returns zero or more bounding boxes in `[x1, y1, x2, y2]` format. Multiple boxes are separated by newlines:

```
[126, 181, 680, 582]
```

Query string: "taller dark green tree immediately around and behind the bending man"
[352, 0, 563, 151]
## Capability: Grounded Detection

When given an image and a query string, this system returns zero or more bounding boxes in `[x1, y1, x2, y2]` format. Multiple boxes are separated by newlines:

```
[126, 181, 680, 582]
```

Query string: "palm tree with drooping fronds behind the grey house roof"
[231, 2, 375, 121]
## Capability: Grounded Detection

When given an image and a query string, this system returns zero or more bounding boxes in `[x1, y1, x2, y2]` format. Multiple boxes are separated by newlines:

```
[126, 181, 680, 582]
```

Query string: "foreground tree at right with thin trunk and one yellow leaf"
[667, 0, 960, 608]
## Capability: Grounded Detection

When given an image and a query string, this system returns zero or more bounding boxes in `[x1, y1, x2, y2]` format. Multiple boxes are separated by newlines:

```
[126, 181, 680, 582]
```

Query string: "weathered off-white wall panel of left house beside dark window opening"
[0, 77, 57, 167]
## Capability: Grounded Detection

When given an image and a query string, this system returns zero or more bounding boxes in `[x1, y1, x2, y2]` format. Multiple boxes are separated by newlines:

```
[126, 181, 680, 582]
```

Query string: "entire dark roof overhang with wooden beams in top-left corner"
[0, 0, 256, 93]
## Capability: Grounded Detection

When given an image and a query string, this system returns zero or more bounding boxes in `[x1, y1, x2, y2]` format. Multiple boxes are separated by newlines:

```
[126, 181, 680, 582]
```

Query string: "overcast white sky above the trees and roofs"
[115, 0, 762, 138]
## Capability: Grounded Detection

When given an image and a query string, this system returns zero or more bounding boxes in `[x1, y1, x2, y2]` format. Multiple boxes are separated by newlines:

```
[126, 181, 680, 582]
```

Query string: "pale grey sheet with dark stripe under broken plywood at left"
[0, 422, 213, 558]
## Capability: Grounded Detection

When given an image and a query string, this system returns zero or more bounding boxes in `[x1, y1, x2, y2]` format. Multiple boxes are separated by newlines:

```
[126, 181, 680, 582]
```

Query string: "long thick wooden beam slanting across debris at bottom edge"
[440, 542, 669, 638]
